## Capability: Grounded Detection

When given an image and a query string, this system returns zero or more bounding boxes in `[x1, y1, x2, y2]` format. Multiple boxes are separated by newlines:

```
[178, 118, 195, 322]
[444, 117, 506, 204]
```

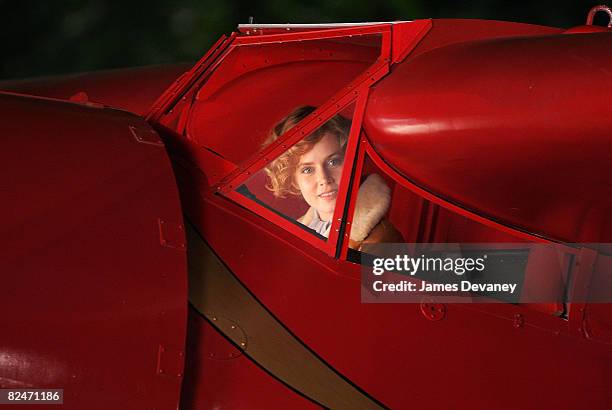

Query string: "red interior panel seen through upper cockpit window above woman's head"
[186, 35, 381, 166]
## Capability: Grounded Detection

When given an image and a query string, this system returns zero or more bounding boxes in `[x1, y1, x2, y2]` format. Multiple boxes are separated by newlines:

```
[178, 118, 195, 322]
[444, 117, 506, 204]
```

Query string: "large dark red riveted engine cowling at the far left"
[0, 94, 187, 409]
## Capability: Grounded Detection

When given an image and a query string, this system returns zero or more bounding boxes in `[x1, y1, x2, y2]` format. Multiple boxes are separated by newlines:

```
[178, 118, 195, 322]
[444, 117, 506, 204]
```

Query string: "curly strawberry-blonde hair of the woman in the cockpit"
[263, 105, 351, 198]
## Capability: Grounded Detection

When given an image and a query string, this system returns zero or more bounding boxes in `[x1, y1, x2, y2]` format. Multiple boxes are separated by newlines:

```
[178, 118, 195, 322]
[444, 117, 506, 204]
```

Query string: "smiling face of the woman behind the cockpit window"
[295, 133, 344, 221]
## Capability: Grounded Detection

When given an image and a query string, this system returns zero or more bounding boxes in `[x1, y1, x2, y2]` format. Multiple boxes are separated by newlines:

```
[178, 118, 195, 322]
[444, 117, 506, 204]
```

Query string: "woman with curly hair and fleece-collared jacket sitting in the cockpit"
[265, 106, 403, 249]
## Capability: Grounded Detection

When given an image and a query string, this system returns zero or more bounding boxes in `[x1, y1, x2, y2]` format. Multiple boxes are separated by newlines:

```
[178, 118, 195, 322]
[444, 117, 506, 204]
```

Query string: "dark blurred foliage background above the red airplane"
[0, 0, 610, 79]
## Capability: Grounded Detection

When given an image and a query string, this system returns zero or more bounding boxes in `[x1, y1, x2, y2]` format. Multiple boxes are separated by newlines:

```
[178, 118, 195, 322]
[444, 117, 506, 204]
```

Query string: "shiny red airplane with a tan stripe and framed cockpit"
[0, 7, 612, 409]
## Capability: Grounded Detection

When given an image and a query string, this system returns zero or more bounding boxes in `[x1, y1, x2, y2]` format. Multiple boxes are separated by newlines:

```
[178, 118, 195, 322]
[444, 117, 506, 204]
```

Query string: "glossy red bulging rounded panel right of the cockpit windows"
[364, 33, 612, 242]
